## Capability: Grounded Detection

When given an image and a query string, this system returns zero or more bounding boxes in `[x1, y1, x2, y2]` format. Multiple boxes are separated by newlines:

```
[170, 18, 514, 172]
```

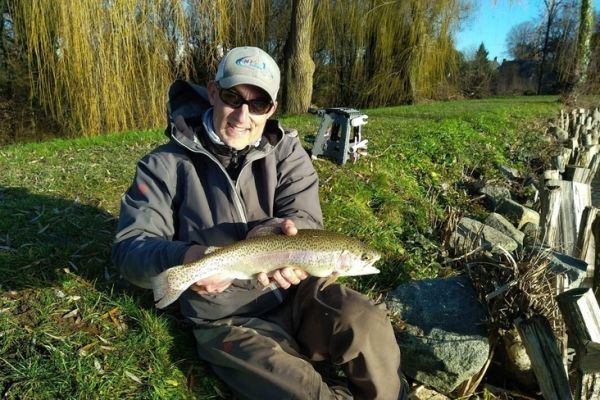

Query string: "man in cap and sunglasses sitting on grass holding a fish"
[113, 47, 406, 400]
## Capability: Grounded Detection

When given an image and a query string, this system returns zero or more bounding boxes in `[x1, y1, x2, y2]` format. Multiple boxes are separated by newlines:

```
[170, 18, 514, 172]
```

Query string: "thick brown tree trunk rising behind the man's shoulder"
[282, 0, 315, 114]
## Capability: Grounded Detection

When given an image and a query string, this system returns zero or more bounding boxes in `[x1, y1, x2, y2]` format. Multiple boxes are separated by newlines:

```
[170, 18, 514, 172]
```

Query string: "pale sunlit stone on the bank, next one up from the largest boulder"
[450, 217, 519, 254]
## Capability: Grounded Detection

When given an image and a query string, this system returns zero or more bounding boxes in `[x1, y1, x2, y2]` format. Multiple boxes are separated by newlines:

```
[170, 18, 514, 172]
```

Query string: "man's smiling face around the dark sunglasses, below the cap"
[208, 81, 277, 150]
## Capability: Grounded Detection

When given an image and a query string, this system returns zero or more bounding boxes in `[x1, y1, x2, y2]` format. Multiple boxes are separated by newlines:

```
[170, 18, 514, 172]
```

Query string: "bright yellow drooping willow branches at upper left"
[9, 0, 195, 135]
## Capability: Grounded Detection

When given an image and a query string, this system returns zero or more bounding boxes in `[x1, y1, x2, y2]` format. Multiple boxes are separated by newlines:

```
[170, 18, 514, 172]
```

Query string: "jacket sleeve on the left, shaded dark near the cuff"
[112, 154, 189, 288]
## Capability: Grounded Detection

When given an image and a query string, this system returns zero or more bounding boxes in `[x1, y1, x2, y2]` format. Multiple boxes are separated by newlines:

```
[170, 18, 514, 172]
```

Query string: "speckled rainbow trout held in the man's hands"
[152, 229, 380, 308]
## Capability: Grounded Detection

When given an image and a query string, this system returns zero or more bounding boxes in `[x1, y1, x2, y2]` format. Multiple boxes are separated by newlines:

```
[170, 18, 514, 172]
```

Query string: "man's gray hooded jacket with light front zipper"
[112, 81, 323, 321]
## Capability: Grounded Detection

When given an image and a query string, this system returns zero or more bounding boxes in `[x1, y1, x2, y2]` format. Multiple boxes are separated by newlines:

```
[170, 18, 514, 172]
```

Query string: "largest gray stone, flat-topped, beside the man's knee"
[386, 277, 490, 394]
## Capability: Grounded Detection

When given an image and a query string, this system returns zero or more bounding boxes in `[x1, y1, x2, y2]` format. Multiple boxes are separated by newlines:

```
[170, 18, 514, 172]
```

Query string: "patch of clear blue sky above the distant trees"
[456, 0, 599, 63]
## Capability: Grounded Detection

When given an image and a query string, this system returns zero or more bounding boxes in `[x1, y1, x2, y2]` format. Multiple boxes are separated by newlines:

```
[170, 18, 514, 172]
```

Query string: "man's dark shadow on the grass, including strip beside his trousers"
[0, 187, 230, 397]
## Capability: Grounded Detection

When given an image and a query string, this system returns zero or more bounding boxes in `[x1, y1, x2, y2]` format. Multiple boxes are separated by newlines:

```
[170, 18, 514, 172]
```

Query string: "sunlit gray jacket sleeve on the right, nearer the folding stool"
[274, 136, 323, 229]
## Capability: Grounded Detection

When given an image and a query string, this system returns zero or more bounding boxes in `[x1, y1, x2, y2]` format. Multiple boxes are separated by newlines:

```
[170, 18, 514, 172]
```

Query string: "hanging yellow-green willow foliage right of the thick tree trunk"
[315, 0, 465, 106]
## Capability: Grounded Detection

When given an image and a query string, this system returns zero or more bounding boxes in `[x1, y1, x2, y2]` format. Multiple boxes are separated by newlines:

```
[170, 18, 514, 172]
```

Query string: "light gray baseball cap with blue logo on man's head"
[215, 46, 280, 101]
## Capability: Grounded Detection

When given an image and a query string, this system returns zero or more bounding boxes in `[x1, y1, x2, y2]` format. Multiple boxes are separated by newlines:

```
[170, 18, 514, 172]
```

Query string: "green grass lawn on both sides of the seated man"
[0, 97, 559, 399]
